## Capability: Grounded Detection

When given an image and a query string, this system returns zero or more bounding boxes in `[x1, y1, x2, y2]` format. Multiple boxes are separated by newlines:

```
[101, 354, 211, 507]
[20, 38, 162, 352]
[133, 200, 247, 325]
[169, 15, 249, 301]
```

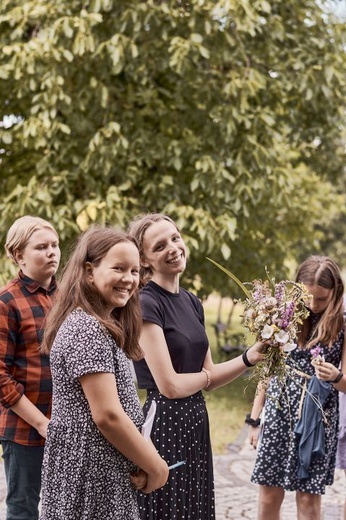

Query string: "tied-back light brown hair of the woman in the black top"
[127, 213, 180, 287]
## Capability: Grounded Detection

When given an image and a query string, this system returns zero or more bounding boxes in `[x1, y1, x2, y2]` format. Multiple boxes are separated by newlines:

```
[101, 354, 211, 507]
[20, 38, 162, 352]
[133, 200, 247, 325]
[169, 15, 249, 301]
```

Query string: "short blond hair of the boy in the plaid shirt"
[5, 215, 59, 264]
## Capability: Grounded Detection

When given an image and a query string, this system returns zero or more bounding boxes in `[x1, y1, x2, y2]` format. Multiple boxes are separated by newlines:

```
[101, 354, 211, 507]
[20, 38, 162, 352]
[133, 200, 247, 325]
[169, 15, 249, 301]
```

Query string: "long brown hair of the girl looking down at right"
[296, 255, 344, 348]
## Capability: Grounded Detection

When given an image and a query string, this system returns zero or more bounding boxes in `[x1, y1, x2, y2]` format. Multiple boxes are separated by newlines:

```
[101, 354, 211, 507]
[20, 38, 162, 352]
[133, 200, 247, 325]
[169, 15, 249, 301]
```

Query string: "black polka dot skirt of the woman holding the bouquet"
[139, 390, 215, 520]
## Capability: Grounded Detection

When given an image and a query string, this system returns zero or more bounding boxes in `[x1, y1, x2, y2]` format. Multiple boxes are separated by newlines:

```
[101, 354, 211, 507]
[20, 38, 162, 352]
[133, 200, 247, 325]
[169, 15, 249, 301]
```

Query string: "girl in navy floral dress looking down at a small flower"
[250, 256, 346, 520]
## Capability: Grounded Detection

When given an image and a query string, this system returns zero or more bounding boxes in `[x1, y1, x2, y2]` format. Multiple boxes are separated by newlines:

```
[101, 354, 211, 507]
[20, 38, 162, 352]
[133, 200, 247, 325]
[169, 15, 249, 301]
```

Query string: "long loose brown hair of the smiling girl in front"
[42, 225, 143, 360]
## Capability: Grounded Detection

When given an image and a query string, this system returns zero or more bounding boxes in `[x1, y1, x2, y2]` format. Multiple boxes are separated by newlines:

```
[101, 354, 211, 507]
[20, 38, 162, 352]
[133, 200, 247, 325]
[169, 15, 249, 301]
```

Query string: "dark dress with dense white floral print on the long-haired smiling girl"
[40, 309, 144, 520]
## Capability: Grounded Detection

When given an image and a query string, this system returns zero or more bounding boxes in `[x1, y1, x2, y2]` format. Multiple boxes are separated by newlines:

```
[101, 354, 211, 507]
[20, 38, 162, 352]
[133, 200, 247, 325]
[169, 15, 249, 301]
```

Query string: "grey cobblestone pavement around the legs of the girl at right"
[0, 429, 346, 520]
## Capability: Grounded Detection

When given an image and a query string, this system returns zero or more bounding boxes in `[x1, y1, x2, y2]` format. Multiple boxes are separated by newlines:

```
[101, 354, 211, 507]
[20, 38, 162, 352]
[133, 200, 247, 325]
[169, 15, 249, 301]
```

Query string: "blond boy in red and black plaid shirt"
[0, 216, 60, 520]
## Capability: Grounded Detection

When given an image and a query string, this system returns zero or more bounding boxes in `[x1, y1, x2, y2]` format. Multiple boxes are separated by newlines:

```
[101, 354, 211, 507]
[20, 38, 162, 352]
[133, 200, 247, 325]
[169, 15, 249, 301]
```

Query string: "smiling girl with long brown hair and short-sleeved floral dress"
[41, 226, 168, 520]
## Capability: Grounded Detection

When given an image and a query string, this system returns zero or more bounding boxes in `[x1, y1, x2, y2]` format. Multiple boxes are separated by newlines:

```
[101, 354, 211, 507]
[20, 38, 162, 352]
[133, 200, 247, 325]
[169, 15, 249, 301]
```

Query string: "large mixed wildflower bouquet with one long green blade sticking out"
[208, 258, 311, 384]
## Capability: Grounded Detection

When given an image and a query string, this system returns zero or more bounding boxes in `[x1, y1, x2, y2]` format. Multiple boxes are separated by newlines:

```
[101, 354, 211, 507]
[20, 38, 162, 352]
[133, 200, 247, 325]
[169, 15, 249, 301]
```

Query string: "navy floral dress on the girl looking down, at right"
[251, 318, 344, 495]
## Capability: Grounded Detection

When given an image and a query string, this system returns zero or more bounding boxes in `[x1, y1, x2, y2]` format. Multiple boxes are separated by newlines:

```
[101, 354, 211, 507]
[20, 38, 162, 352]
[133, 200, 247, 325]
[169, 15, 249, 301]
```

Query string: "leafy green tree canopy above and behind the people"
[0, 0, 346, 293]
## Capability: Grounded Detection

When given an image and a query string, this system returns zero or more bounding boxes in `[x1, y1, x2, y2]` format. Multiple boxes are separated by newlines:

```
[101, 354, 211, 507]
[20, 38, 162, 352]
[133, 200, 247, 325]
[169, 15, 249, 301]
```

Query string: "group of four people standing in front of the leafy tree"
[0, 213, 346, 520]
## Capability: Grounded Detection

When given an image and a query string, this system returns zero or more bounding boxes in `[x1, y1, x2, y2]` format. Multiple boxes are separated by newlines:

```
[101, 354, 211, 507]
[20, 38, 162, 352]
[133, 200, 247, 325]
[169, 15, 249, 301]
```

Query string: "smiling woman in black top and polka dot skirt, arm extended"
[129, 213, 263, 520]
